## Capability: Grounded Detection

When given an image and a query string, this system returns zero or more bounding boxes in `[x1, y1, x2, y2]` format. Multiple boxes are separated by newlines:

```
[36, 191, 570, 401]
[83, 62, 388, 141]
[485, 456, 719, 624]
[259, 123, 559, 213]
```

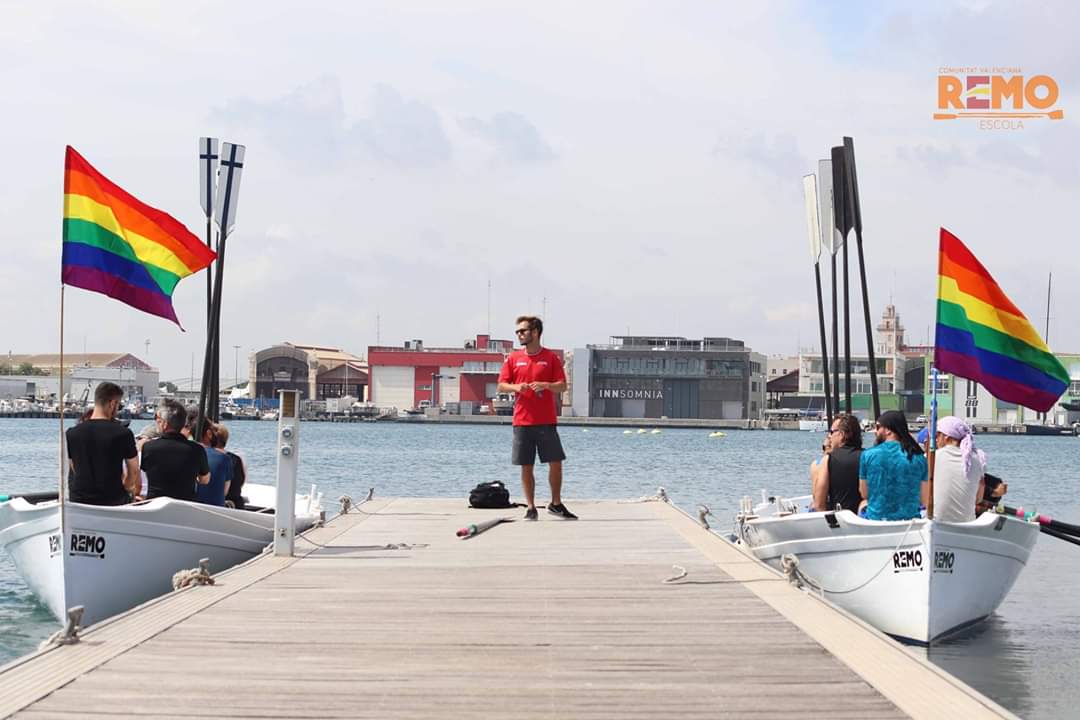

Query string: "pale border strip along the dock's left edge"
[0, 499, 393, 718]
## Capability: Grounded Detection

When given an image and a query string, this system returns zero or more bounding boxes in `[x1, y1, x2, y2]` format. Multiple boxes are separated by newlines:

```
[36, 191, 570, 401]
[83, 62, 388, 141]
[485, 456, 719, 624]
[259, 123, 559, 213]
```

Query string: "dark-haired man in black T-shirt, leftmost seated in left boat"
[66, 382, 139, 505]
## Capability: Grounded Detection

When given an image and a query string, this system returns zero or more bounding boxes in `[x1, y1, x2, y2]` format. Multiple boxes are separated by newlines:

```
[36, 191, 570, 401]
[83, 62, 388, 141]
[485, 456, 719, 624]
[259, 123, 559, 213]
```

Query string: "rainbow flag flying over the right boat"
[934, 228, 1069, 412]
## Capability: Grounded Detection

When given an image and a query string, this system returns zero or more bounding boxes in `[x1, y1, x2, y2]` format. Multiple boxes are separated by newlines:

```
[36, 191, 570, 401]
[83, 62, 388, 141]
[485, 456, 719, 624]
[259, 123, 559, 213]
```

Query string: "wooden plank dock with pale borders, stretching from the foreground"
[0, 499, 1011, 720]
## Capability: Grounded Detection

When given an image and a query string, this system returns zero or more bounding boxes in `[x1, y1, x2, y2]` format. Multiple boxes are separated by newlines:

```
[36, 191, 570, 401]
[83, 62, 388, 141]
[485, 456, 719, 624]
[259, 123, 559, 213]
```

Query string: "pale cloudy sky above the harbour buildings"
[0, 0, 1080, 379]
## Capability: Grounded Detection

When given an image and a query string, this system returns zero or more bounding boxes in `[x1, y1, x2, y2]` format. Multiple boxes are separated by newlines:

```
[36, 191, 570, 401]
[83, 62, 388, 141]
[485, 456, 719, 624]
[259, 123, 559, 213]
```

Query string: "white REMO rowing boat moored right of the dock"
[733, 498, 1039, 644]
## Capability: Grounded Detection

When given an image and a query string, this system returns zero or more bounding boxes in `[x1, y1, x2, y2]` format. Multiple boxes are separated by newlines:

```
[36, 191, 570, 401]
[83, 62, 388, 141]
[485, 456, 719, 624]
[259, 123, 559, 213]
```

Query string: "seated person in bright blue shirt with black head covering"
[859, 410, 928, 520]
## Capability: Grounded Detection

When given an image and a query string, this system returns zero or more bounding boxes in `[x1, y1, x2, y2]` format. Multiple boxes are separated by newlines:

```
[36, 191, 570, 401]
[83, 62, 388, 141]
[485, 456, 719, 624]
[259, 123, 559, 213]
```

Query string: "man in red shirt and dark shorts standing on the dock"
[499, 315, 578, 520]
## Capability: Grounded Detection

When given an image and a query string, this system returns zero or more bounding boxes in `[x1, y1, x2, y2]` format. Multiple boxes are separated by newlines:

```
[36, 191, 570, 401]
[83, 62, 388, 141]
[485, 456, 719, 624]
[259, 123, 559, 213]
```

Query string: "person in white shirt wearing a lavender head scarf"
[934, 416, 986, 522]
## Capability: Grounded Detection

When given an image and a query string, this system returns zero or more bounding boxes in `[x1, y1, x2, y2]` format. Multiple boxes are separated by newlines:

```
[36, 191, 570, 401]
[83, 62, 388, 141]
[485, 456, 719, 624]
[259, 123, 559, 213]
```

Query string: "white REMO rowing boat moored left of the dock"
[0, 484, 322, 626]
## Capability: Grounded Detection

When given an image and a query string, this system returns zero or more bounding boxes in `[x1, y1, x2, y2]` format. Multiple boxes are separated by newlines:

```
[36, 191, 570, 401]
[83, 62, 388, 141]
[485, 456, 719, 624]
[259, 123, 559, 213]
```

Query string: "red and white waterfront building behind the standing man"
[367, 335, 563, 412]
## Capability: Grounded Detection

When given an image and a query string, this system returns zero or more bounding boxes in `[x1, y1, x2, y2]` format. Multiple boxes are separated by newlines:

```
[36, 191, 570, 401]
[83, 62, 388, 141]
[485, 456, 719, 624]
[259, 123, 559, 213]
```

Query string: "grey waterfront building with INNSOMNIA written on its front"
[569, 336, 766, 420]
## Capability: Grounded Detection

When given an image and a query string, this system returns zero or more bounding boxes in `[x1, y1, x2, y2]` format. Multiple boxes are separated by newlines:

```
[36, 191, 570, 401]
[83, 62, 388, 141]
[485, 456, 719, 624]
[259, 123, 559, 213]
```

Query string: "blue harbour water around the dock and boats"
[0, 419, 1080, 718]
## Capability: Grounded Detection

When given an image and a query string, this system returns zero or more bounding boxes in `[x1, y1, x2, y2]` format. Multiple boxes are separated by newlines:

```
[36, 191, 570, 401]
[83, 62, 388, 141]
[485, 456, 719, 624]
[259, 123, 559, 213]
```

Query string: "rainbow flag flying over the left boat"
[60, 146, 217, 329]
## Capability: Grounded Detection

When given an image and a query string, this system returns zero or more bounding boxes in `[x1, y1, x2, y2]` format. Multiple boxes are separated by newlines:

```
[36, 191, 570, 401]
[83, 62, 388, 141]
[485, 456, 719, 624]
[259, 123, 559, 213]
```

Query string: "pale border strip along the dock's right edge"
[652, 503, 1018, 720]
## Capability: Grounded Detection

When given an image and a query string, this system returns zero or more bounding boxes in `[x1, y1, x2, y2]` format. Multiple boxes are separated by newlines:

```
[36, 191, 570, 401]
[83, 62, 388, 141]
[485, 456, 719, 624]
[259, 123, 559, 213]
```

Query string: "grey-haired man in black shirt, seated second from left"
[143, 400, 210, 501]
